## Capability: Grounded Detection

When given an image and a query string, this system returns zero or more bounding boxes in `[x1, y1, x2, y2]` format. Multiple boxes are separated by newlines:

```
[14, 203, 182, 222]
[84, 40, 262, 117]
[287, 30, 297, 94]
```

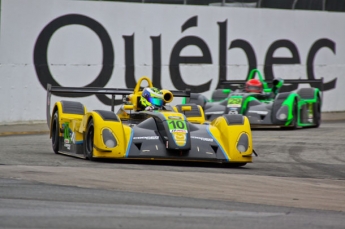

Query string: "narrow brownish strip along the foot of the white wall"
[0, 111, 345, 136]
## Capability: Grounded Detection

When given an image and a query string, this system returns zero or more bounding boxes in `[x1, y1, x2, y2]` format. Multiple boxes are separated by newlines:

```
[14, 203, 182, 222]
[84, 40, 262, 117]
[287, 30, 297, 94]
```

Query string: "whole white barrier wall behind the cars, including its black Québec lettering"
[0, 0, 345, 124]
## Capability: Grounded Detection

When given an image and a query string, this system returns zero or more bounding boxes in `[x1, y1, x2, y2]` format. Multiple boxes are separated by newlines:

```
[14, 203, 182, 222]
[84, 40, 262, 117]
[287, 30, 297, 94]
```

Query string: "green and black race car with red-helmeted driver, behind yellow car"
[185, 69, 323, 129]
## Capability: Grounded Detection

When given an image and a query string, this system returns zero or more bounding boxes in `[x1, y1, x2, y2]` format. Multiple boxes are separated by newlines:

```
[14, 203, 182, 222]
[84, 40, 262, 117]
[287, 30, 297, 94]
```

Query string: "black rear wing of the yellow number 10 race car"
[46, 84, 190, 128]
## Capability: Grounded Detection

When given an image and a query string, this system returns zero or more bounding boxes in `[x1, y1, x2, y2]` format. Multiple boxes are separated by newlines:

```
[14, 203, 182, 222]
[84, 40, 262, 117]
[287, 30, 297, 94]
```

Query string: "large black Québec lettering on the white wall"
[34, 14, 337, 105]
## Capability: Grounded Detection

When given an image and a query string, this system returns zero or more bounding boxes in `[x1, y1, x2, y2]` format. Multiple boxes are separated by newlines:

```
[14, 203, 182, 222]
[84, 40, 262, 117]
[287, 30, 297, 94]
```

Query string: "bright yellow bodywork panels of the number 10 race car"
[50, 77, 253, 163]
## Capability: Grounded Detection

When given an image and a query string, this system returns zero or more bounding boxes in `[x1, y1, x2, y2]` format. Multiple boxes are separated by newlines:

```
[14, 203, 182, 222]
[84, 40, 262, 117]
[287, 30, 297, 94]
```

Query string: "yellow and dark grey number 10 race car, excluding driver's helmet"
[47, 77, 256, 166]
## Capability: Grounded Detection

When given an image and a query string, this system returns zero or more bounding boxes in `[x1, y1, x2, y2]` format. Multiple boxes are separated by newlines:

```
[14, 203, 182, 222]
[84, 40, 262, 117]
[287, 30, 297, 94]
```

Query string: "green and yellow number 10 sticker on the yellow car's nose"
[167, 119, 188, 146]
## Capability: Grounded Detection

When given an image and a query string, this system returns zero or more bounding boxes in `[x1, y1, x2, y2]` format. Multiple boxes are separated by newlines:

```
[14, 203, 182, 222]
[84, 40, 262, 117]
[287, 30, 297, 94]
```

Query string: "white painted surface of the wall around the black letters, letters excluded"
[0, 0, 345, 124]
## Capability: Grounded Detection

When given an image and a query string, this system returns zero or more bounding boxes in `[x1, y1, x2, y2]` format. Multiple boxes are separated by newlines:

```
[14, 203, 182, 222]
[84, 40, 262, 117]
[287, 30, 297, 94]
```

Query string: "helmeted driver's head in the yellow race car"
[140, 87, 164, 111]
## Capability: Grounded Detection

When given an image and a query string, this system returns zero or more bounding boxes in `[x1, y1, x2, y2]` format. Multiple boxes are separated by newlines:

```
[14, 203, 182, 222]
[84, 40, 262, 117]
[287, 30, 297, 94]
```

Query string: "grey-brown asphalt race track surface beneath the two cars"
[0, 121, 345, 228]
